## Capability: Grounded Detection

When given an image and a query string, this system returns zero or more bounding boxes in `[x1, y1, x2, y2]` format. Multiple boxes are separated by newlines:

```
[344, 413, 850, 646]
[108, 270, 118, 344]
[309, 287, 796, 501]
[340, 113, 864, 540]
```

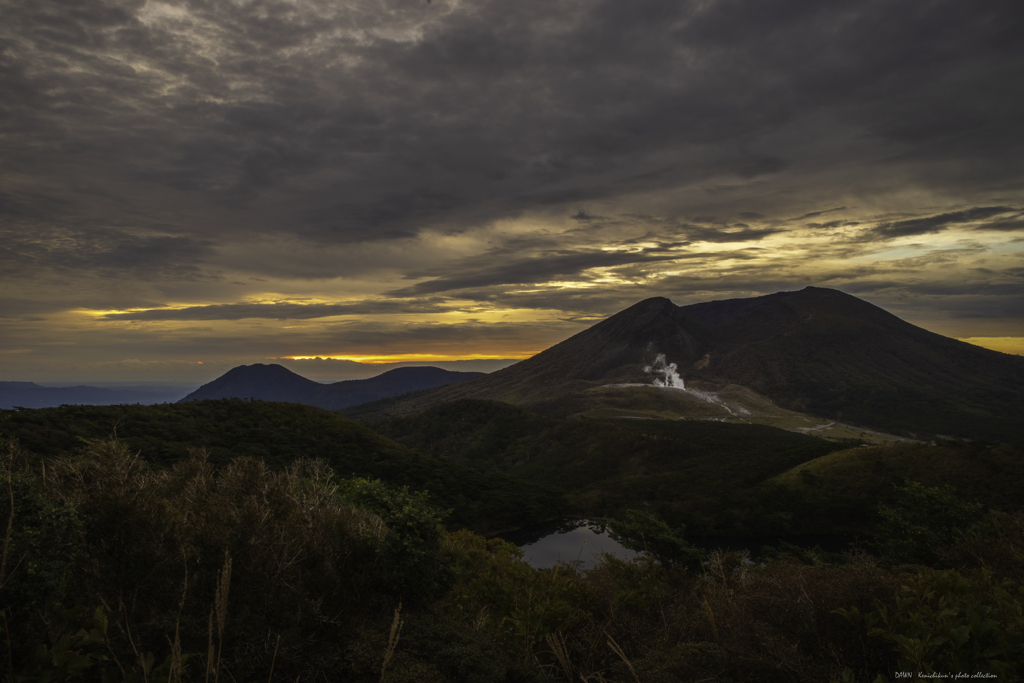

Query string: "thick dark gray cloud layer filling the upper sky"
[0, 0, 1024, 250]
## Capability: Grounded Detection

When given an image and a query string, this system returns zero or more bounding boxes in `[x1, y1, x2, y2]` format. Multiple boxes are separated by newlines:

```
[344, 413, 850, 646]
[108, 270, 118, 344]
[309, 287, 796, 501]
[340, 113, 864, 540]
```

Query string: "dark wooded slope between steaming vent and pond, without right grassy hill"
[371, 400, 841, 536]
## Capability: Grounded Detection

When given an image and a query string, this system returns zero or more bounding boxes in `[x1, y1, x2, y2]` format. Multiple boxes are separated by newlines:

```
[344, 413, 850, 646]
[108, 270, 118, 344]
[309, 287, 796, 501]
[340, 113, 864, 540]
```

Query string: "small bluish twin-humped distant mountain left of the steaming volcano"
[179, 364, 481, 410]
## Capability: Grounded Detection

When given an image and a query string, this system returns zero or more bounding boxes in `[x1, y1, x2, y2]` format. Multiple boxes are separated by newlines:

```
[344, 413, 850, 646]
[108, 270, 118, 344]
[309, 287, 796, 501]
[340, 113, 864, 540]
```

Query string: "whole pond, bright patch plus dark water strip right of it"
[499, 517, 853, 569]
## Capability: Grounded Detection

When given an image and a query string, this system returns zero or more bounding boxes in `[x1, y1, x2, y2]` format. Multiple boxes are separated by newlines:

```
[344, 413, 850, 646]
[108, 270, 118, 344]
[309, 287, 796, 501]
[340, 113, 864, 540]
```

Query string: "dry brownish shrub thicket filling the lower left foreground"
[0, 441, 536, 681]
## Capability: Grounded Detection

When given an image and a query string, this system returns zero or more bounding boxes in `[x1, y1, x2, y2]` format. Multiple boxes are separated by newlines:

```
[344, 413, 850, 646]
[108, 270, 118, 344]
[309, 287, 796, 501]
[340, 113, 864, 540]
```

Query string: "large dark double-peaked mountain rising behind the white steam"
[368, 287, 1024, 441]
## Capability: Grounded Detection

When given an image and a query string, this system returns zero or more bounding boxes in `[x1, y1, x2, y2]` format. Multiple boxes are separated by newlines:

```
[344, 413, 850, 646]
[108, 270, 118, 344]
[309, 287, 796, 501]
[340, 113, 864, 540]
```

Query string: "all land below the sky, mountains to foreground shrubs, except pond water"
[0, 288, 1024, 683]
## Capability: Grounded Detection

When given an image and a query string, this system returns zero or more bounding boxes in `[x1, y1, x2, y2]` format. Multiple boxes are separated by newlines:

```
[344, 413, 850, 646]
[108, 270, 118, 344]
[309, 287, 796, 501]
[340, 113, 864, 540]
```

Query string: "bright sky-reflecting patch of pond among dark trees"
[501, 519, 637, 569]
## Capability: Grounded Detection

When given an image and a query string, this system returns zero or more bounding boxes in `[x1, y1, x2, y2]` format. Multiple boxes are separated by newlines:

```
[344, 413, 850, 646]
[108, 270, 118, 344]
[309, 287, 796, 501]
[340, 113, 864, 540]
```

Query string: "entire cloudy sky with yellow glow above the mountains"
[0, 0, 1024, 380]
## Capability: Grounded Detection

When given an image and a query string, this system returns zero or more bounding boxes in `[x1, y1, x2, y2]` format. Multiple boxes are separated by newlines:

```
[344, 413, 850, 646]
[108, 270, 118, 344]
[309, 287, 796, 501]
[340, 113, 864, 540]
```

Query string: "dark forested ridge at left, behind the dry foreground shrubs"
[0, 399, 561, 531]
